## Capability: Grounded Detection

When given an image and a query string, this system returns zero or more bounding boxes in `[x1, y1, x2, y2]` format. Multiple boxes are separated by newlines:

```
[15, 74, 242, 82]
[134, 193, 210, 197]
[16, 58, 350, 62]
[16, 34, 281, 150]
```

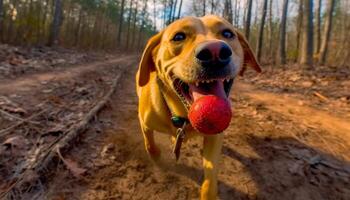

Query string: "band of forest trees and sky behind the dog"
[0, 0, 350, 66]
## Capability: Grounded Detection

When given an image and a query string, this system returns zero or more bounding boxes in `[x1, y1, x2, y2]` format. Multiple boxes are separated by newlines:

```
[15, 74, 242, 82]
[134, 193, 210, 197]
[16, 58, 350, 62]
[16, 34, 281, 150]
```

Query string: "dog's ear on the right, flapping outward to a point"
[236, 31, 261, 76]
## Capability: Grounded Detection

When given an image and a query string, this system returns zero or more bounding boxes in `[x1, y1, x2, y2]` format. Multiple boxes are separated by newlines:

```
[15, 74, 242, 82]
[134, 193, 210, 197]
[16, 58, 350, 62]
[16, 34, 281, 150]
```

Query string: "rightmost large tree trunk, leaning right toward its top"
[320, 0, 335, 65]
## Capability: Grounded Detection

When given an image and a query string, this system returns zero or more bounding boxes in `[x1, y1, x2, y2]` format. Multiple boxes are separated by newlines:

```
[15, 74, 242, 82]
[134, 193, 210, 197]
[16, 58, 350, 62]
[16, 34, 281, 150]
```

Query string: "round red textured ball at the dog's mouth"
[188, 95, 232, 135]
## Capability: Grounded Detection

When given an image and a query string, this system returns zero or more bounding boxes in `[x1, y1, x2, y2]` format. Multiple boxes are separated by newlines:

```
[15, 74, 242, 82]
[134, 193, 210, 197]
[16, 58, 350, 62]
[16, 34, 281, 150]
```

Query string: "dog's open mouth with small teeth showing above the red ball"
[173, 77, 234, 107]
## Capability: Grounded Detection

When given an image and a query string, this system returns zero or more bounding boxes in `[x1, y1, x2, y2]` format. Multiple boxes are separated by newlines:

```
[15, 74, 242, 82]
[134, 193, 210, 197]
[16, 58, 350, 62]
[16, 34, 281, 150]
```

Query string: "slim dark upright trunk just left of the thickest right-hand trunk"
[278, 0, 288, 64]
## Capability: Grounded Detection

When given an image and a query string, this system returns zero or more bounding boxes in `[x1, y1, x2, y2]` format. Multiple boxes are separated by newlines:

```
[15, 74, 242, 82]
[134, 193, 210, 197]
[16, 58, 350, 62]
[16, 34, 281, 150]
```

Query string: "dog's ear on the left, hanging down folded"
[137, 32, 163, 87]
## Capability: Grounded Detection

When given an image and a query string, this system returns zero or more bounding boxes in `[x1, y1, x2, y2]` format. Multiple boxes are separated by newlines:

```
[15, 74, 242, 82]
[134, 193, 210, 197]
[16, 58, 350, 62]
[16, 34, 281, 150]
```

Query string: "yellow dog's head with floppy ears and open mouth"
[138, 16, 261, 106]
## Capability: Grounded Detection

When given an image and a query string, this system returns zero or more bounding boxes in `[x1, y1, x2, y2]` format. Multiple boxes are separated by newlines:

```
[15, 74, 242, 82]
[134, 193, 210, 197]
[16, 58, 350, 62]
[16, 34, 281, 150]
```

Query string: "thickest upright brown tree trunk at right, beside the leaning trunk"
[300, 0, 314, 67]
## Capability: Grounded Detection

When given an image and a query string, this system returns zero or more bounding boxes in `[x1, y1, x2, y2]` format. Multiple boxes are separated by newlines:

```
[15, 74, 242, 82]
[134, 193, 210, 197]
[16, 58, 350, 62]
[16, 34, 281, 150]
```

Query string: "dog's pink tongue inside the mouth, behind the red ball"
[189, 81, 227, 102]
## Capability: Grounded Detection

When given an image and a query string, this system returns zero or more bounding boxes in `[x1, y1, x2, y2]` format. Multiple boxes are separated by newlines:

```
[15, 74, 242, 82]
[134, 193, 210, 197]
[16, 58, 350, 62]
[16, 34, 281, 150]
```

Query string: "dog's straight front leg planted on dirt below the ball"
[201, 134, 223, 200]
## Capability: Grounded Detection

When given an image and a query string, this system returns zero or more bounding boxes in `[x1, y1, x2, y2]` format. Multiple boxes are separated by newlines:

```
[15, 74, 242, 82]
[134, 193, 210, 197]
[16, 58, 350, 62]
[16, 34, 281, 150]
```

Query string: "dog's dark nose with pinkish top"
[195, 41, 232, 66]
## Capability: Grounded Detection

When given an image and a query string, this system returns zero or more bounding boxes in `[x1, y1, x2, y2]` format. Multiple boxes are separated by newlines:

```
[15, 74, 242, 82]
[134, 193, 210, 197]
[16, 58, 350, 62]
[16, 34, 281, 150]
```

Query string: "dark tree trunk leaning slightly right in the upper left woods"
[48, 0, 62, 46]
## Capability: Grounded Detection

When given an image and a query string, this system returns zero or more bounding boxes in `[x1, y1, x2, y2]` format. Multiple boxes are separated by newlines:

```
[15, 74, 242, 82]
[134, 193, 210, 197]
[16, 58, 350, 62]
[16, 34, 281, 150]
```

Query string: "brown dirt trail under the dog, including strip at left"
[0, 59, 350, 200]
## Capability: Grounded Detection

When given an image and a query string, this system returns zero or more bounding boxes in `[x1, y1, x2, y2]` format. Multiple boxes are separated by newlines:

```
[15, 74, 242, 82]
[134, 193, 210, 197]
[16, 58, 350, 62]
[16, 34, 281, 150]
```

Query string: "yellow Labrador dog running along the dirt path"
[136, 15, 261, 200]
